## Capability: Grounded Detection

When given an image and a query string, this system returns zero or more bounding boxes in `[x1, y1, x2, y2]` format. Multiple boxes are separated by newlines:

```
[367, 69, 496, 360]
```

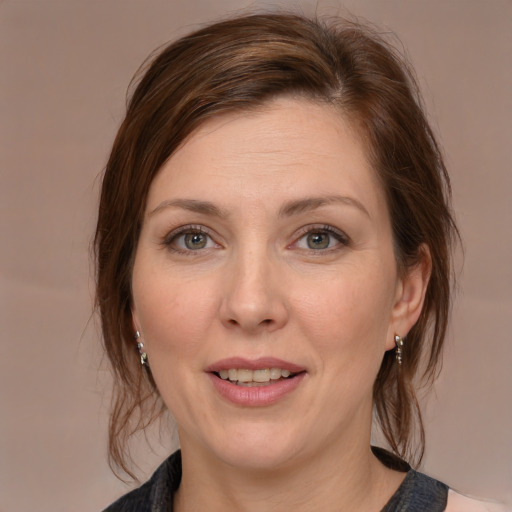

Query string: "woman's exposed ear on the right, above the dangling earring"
[386, 244, 432, 350]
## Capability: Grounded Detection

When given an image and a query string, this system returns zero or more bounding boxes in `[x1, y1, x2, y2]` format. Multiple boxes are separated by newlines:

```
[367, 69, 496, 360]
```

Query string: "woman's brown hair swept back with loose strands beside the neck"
[95, 14, 457, 476]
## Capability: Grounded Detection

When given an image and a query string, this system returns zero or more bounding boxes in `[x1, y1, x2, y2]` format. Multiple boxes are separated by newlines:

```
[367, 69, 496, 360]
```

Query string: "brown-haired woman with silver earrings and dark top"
[96, 14, 504, 512]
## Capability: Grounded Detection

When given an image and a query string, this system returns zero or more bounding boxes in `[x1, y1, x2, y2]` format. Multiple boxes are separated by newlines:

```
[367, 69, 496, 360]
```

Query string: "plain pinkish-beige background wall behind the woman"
[0, 0, 512, 512]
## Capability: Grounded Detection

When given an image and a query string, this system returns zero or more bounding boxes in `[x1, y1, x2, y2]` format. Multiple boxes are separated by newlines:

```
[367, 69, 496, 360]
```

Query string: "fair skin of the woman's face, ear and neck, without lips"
[132, 98, 429, 512]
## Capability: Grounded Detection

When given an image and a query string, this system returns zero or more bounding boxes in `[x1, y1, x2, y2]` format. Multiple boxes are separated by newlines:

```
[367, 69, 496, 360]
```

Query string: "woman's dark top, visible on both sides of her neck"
[103, 447, 448, 512]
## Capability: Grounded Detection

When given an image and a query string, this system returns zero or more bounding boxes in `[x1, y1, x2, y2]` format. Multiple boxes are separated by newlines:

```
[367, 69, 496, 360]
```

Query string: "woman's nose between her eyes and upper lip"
[220, 246, 288, 334]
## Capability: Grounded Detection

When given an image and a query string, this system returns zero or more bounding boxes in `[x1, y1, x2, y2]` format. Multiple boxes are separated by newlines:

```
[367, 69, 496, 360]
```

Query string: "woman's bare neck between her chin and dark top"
[175, 434, 404, 512]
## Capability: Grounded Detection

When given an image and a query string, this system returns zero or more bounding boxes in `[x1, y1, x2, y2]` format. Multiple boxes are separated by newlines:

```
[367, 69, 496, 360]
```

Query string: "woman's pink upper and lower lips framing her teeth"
[205, 357, 306, 407]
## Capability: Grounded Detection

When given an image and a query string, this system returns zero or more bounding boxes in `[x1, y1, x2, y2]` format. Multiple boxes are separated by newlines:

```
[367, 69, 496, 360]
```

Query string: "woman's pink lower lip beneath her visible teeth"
[208, 372, 306, 407]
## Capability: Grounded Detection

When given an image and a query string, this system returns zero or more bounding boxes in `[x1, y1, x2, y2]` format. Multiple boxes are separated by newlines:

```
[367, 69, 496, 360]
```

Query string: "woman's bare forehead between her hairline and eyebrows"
[148, 97, 382, 217]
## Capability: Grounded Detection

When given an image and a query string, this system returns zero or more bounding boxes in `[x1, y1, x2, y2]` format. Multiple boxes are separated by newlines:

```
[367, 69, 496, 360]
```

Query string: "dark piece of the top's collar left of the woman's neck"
[103, 450, 181, 512]
